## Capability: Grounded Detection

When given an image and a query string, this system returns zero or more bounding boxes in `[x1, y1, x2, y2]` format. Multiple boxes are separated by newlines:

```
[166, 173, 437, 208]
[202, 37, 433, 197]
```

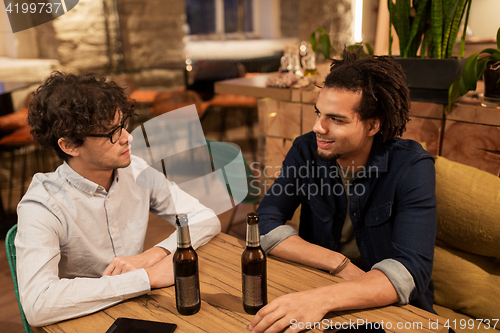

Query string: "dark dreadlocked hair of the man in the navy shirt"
[324, 48, 410, 140]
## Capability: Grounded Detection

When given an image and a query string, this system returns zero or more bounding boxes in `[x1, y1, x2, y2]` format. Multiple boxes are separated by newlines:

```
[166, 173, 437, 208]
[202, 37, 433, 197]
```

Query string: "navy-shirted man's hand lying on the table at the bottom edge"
[249, 287, 328, 333]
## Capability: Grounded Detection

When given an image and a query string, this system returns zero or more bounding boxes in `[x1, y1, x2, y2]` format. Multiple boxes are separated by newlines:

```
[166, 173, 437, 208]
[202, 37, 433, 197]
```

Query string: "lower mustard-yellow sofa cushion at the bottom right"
[432, 242, 500, 326]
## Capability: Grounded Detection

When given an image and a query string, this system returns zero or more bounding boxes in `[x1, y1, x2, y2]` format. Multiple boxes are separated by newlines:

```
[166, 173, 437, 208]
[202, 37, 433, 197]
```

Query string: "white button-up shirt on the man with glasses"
[15, 156, 220, 326]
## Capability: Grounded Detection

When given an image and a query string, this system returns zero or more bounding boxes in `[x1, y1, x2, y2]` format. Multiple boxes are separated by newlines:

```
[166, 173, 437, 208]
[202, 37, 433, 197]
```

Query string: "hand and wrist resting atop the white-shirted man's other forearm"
[102, 246, 170, 276]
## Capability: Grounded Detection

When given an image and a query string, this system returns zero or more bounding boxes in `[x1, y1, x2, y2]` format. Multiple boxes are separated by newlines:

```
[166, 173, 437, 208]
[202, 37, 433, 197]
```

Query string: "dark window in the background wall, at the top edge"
[186, 0, 254, 35]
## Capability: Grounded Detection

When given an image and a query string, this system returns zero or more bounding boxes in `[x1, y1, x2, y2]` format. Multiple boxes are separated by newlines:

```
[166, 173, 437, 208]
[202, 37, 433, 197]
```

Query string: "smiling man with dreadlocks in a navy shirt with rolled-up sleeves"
[250, 51, 436, 332]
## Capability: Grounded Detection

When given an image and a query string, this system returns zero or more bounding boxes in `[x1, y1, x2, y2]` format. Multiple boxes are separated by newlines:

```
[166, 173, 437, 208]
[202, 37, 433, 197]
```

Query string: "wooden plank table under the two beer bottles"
[33, 233, 447, 333]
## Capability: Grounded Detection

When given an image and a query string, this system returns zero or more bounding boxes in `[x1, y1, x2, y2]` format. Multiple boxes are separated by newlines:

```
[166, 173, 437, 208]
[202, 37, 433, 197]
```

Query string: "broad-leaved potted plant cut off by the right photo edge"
[447, 28, 500, 111]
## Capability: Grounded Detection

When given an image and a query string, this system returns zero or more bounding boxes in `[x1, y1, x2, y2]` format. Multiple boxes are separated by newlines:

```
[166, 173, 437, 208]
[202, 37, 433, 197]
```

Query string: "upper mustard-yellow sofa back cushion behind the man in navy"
[436, 157, 500, 259]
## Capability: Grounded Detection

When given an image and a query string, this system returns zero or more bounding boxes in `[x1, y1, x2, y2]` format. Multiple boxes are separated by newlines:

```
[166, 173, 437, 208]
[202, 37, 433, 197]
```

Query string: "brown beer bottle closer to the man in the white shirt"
[173, 214, 201, 315]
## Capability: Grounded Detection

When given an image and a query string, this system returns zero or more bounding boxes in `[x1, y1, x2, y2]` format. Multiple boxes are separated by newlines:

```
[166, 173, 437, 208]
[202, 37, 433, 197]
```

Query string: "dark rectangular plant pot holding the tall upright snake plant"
[393, 57, 466, 104]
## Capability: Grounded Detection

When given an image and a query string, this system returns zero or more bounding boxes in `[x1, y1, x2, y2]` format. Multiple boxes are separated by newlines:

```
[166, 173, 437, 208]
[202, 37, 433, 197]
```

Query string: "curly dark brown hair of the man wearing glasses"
[28, 72, 134, 161]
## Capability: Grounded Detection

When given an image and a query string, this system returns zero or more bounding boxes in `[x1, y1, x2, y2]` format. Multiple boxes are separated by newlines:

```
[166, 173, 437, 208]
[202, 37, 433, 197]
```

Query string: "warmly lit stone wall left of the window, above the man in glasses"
[35, 0, 185, 87]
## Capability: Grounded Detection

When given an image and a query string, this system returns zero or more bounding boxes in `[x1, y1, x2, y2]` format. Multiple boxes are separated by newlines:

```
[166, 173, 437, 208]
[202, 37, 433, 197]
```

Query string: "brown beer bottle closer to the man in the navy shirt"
[241, 213, 267, 314]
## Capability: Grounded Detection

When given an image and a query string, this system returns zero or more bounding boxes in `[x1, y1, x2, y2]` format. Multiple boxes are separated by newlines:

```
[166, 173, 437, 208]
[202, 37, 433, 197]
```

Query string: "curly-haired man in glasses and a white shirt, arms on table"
[15, 72, 220, 326]
